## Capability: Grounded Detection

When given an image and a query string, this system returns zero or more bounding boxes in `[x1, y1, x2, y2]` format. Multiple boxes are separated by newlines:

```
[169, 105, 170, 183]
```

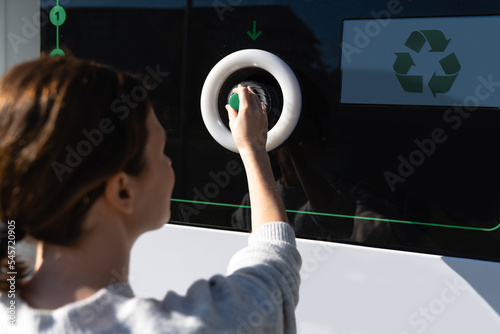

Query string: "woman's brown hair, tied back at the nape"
[0, 57, 151, 291]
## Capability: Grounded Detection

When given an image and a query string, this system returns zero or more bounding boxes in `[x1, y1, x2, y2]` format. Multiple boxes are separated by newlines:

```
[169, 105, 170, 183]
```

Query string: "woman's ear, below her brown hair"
[103, 172, 134, 214]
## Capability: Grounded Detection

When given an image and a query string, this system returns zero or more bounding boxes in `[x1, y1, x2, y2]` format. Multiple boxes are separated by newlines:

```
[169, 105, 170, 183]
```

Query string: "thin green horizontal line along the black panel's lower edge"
[171, 198, 500, 232]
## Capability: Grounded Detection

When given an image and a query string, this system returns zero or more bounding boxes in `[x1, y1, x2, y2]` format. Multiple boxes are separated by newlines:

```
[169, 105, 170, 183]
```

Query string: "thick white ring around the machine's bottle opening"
[200, 49, 302, 153]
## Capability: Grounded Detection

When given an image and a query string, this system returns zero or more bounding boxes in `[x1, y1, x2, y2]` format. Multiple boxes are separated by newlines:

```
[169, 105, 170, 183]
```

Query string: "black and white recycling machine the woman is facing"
[0, 0, 500, 334]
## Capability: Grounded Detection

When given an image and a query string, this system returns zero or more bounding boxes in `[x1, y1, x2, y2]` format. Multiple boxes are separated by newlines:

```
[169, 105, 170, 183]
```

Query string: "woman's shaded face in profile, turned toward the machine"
[133, 109, 175, 229]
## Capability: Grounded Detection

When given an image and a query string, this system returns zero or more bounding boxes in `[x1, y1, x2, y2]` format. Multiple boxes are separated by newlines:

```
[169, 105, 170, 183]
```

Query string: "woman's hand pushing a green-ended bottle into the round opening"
[226, 85, 267, 153]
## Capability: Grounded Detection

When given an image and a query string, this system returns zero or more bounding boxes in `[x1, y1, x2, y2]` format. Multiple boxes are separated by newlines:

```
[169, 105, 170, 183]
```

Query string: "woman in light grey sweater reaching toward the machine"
[0, 57, 301, 334]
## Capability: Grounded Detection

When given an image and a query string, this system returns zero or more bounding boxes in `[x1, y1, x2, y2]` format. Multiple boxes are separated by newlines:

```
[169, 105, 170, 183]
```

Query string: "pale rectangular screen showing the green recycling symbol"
[340, 16, 500, 107]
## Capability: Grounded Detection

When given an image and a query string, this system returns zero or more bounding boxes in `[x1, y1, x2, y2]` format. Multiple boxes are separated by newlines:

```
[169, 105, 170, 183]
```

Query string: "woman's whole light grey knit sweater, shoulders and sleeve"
[0, 222, 301, 334]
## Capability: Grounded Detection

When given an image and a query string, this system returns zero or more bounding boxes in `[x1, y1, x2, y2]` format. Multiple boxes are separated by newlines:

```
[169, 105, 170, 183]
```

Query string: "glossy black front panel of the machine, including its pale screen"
[42, 0, 500, 261]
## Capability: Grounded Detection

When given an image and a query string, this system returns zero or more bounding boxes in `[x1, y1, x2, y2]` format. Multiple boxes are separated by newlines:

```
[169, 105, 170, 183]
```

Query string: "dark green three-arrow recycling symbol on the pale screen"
[393, 30, 460, 97]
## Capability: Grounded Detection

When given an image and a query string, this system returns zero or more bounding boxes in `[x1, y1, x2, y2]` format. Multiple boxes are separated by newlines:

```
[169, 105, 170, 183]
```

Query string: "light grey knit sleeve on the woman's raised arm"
[162, 222, 301, 334]
